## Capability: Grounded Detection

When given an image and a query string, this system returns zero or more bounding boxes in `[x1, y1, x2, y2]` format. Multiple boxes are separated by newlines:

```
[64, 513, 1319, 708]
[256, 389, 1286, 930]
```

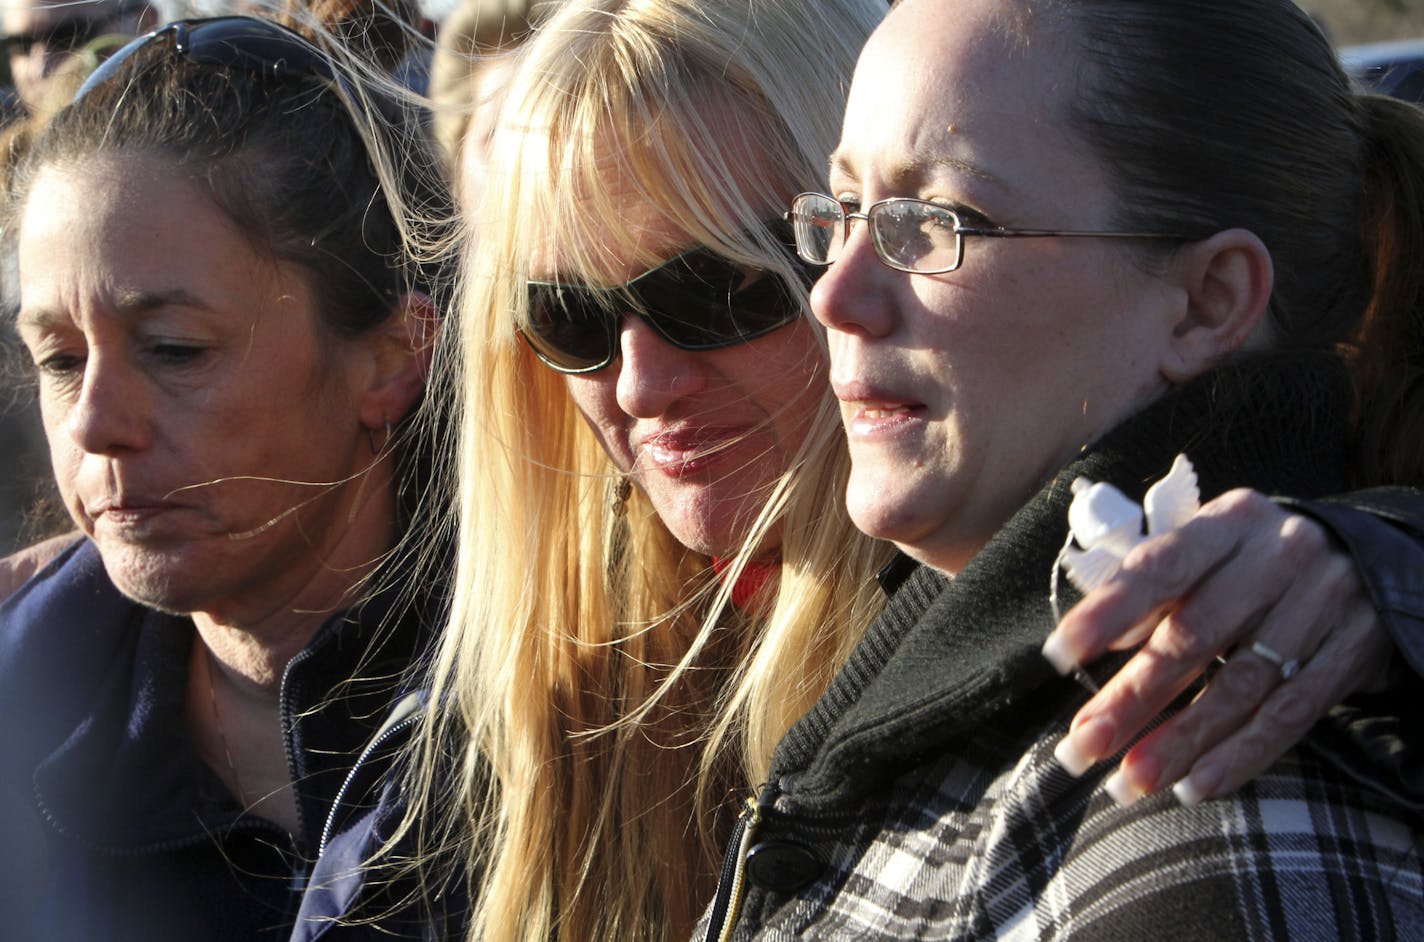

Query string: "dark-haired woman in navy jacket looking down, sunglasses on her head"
[0, 9, 451, 942]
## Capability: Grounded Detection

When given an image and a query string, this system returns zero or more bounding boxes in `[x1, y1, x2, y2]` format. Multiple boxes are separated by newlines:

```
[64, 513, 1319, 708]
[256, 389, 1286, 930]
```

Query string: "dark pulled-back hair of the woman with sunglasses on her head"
[11, 18, 453, 336]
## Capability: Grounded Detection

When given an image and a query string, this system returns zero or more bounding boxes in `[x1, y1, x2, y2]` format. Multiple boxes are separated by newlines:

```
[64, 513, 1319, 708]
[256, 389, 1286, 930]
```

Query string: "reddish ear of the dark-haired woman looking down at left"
[360, 292, 440, 430]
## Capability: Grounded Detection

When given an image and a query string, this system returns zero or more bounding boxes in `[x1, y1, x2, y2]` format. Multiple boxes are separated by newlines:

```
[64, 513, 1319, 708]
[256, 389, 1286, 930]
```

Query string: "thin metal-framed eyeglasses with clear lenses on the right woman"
[786, 194, 1190, 275]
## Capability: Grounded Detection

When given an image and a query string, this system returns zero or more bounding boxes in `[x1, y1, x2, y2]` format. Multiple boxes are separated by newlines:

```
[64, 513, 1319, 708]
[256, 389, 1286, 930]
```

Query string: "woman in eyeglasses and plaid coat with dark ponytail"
[697, 0, 1424, 939]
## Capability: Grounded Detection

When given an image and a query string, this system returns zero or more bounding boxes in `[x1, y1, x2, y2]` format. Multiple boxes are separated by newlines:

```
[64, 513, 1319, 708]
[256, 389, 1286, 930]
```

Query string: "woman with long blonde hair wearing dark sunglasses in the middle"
[309, 0, 1424, 941]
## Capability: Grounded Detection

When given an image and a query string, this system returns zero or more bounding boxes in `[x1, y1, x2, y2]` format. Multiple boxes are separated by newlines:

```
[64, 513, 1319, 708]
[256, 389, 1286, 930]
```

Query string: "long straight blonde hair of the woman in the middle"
[412, 0, 887, 942]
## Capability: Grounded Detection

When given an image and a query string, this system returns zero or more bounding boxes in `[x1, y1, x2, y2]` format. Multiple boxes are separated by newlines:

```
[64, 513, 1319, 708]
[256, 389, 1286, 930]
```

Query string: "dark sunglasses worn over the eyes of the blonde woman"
[520, 222, 820, 373]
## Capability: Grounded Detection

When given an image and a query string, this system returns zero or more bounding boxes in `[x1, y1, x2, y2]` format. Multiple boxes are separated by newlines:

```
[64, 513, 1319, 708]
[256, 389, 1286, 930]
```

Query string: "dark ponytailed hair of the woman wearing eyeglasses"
[1059, 0, 1424, 484]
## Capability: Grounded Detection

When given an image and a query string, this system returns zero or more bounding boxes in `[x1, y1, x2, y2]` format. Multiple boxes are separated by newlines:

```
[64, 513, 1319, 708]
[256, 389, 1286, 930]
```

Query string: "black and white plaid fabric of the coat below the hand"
[732, 723, 1424, 942]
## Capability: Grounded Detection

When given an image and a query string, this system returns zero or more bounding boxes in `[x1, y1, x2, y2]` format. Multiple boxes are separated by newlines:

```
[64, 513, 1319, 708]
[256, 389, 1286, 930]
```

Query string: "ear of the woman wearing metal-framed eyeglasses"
[1161, 229, 1276, 384]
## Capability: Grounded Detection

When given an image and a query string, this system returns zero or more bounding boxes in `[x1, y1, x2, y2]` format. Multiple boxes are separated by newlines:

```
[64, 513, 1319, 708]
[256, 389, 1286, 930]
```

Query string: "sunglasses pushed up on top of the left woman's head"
[74, 16, 342, 101]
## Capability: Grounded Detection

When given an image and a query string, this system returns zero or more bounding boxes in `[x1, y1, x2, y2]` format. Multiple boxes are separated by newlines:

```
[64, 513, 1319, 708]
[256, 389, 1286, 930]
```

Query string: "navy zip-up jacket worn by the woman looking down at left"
[0, 541, 423, 942]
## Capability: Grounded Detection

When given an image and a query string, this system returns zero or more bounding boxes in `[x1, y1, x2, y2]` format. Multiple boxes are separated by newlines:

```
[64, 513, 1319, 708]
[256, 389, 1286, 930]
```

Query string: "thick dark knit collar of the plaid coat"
[773, 359, 1350, 804]
